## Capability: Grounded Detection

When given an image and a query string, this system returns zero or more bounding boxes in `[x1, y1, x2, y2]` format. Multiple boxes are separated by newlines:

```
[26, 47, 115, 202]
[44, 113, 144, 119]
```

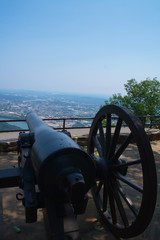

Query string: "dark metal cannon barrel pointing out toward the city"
[26, 113, 95, 201]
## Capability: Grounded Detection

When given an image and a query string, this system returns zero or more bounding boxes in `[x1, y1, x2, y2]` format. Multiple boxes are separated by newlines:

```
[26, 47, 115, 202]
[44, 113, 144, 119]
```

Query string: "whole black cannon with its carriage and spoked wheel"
[0, 105, 157, 240]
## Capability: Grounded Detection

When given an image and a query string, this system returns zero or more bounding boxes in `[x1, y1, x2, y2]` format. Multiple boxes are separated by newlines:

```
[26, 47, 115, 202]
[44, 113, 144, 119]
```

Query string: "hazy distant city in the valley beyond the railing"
[0, 90, 107, 129]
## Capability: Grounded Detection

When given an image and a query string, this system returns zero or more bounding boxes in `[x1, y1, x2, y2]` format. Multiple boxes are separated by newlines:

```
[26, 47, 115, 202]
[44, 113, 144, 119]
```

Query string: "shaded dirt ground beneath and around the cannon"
[0, 141, 160, 240]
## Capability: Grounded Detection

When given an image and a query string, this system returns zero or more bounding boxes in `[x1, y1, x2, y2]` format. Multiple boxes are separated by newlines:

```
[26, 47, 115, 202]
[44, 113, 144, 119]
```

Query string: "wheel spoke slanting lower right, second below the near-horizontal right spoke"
[115, 181, 138, 217]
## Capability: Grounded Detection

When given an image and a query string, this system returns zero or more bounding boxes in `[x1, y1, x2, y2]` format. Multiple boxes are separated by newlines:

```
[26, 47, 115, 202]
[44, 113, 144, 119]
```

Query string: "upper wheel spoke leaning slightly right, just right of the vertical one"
[109, 118, 122, 159]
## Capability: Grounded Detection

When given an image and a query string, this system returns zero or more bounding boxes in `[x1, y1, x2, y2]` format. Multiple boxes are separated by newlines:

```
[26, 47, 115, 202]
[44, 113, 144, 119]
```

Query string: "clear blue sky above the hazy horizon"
[0, 0, 160, 95]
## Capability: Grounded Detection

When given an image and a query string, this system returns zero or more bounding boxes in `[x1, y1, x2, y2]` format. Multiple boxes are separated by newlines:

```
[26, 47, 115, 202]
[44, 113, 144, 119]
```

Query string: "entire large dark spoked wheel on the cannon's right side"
[88, 105, 157, 238]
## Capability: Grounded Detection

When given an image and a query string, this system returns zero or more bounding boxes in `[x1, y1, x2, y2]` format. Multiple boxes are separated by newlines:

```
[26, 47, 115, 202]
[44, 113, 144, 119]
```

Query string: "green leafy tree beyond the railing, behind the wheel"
[105, 78, 160, 116]
